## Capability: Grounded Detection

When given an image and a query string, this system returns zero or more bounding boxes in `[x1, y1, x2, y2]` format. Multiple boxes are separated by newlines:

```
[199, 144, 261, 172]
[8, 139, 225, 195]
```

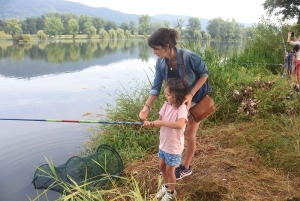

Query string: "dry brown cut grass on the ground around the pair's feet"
[124, 127, 300, 201]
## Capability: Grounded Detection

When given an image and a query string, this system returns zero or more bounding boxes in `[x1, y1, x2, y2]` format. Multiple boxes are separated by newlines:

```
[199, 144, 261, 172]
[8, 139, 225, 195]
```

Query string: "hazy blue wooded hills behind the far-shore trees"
[0, 0, 251, 30]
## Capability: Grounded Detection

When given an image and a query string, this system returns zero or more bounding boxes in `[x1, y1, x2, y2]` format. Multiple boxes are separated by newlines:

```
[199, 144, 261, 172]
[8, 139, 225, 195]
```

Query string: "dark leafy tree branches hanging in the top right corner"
[263, 0, 300, 24]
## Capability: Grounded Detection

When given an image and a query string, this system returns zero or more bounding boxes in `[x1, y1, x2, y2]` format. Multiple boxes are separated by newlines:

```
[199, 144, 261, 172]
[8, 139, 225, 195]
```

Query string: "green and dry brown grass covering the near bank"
[31, 19, 300, 201]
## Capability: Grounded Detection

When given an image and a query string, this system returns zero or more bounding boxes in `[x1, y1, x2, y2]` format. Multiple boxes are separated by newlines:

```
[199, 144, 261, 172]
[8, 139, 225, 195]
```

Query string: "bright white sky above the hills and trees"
[69, 0, 266, 23]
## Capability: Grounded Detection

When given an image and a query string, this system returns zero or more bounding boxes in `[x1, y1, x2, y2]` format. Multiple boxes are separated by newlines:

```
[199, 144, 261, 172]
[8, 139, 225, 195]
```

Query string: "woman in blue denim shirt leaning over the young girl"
[139, 28, 211, 180]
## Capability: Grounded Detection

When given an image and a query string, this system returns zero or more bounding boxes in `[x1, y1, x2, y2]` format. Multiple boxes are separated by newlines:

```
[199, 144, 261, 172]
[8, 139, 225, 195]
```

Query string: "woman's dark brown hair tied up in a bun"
[148, 28, 178, 48]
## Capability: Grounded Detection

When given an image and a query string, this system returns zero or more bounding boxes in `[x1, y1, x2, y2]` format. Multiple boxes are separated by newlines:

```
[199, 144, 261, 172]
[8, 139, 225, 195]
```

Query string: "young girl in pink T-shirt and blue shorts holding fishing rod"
[144, 78, 188, 201]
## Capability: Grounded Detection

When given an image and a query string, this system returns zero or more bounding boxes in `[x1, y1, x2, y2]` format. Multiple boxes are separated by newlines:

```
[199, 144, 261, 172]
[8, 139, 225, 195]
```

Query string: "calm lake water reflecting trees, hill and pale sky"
[0, 40, 244, 201]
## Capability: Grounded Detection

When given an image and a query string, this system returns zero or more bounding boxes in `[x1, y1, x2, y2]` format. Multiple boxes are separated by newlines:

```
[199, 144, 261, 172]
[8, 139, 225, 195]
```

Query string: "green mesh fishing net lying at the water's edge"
[32, 144, 124, 192]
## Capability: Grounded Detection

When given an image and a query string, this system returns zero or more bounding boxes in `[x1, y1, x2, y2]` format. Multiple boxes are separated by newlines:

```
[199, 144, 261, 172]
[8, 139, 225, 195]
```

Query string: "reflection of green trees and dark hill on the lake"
[0, 39, 244, 79]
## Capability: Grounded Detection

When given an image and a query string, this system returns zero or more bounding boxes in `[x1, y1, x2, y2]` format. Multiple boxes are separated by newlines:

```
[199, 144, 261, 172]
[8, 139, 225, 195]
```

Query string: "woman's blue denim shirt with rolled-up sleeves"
[150, 48, 212, 103]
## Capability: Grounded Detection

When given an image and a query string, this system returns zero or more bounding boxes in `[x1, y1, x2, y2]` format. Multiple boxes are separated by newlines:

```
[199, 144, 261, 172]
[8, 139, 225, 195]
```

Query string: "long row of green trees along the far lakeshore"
[0, 12, 254, 40]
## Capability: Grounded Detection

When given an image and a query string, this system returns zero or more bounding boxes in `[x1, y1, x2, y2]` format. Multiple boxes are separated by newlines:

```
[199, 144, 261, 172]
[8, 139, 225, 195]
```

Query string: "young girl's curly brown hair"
[165, 78, 188, 107]
